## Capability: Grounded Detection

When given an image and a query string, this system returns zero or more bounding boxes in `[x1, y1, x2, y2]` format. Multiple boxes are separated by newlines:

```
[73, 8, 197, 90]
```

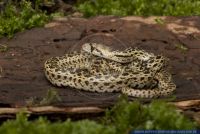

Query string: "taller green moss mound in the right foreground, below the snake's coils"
[103, 96, 196, 134]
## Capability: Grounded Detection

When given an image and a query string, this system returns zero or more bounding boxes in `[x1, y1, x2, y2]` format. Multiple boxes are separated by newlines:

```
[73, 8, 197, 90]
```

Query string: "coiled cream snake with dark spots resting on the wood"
[44, 43, 176, 98]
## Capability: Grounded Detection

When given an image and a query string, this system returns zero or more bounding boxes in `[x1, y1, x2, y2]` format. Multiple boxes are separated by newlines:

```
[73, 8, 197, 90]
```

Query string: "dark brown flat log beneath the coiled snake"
[0, 16, 200, 120]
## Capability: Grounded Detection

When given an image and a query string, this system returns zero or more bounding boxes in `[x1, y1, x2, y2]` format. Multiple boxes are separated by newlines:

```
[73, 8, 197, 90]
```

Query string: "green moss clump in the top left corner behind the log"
[0, 0, 50, 38]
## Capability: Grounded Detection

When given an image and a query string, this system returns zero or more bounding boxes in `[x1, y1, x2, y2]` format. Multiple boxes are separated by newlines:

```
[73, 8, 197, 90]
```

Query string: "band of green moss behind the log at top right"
[77, 0, 200, 17]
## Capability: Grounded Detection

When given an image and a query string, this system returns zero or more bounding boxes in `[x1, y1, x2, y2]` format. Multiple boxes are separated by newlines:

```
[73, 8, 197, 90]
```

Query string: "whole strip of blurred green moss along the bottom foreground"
[0, 97, 197, 134]
